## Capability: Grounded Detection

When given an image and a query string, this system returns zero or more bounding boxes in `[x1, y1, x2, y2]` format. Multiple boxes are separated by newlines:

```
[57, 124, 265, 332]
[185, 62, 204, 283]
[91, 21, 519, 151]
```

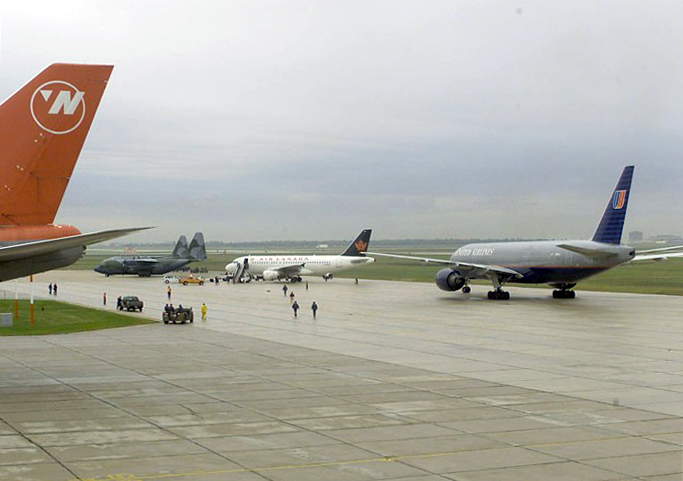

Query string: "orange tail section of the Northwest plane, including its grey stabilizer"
[0, 64, 144, 282]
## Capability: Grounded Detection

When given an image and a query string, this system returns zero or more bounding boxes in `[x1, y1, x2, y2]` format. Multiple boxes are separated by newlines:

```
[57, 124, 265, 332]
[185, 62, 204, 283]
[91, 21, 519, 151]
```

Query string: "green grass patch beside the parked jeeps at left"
[0, 299, 154, 336]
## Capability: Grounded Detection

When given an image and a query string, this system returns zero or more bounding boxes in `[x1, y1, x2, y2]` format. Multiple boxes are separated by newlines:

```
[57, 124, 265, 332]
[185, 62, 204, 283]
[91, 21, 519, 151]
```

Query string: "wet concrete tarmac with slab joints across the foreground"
[0, 271, 683, 481]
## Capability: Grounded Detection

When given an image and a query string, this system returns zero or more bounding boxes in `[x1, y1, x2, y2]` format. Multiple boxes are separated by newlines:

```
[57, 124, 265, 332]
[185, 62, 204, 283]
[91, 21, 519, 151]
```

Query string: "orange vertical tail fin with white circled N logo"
[0, 64, 114, 225]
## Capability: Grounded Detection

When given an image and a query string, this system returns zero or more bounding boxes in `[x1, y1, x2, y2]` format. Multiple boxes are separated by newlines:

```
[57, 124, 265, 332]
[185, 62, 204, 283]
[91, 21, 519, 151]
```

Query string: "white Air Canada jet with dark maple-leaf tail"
[225, 229, 375, 282]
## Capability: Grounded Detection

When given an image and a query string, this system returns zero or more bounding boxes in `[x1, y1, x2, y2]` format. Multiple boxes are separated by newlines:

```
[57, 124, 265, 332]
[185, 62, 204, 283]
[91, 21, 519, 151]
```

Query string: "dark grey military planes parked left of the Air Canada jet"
[94, 232, 206, 277]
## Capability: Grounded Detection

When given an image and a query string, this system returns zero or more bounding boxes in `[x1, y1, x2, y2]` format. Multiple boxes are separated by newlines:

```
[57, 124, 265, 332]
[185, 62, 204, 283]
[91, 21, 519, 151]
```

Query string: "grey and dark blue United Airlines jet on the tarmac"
[368, 166, 683, 299]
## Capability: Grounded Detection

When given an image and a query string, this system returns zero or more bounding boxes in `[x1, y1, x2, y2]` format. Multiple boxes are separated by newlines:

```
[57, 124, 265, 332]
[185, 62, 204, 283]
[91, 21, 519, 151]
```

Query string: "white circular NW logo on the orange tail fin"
[31, 80, 85, 134]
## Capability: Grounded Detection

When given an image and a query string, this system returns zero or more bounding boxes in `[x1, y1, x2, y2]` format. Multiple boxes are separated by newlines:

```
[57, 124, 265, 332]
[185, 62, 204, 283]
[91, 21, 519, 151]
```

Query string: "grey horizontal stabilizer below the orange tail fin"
[0, 227, 151, 262]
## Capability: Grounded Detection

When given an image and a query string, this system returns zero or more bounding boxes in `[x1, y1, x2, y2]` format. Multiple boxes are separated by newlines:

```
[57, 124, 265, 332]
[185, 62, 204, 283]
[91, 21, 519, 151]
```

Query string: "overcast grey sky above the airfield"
[0, 0, 683, 242]
